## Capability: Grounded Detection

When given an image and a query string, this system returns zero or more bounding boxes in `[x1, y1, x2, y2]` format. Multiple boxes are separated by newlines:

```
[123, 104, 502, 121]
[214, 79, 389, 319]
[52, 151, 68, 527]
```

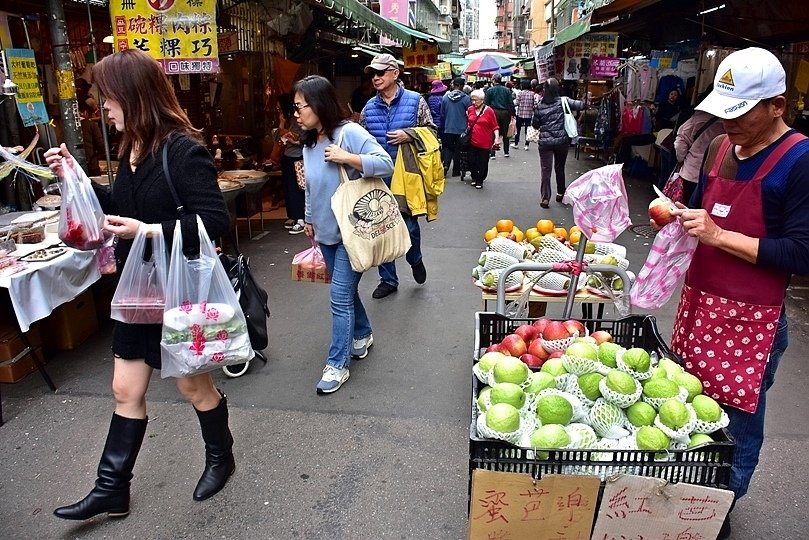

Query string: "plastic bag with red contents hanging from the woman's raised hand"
[59, 158, 112, 251]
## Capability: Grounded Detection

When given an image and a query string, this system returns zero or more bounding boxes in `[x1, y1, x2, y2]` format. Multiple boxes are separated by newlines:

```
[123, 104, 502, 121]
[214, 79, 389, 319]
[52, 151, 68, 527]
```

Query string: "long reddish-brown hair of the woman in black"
[93, 49, 202, 163]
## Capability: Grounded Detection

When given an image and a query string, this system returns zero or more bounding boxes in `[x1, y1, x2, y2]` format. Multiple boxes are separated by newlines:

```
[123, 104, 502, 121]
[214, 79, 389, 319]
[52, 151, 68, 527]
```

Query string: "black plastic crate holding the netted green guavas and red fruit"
[469, 312, 735, 489]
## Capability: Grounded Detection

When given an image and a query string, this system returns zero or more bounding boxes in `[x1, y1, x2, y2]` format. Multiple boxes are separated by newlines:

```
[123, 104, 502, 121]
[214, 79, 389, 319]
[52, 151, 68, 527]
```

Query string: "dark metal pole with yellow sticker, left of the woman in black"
[45, 0, 87, 166]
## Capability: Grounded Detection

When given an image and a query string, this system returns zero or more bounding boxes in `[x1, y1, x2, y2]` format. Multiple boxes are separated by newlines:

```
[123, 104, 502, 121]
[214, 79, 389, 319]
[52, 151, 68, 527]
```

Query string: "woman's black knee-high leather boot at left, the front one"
[53, 414, 148, 520]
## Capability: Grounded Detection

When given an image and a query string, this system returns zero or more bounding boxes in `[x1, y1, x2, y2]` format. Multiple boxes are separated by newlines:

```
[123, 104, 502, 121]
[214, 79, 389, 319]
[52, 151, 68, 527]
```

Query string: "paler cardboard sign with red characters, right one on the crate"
[593, 475, 733, 540]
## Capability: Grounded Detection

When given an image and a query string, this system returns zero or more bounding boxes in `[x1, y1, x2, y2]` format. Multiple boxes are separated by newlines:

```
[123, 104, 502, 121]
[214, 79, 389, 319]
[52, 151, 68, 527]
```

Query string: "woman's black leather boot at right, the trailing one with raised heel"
[194, 392, 236, 501]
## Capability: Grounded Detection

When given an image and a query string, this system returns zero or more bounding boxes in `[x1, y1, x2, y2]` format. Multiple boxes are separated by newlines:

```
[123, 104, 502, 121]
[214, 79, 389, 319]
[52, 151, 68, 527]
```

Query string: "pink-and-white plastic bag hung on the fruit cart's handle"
[563, 163, 632, 242]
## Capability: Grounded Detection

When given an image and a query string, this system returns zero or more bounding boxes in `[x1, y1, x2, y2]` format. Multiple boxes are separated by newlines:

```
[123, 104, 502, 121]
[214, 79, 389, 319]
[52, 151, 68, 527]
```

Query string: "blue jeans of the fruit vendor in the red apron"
[724, 311, 789, 499]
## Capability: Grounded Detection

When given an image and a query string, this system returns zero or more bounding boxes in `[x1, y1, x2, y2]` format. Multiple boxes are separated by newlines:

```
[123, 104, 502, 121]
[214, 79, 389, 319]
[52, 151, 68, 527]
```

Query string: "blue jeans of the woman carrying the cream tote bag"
[320, 242, 371, 369]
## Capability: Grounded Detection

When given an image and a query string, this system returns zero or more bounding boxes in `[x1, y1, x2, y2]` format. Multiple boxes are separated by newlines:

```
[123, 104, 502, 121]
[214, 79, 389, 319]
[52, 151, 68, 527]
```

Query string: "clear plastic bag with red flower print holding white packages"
[160, 217, 255, 379]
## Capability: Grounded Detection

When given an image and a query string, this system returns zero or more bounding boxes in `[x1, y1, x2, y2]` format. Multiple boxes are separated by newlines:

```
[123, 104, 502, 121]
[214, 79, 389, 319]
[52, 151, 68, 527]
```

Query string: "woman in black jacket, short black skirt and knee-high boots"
[45, 49, 236, 520]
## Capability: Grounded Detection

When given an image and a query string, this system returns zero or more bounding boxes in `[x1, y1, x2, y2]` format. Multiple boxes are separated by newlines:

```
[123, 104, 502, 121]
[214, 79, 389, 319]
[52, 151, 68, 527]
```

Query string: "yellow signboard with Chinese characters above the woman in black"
[110, 0, 219, 75]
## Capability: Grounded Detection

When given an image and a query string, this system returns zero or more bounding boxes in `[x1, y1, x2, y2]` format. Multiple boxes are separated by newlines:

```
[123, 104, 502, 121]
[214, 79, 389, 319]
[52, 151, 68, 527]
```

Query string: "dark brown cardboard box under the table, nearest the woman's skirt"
[40, 289, 98, 351]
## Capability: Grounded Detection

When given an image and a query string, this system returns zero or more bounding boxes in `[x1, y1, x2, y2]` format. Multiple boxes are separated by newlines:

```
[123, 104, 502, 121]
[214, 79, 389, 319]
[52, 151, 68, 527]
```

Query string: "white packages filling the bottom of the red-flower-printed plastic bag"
[160, 302, 255, 377]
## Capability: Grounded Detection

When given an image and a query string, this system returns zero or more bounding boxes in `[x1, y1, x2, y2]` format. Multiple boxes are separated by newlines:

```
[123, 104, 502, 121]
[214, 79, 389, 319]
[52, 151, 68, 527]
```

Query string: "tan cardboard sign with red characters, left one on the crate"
[468, 469, 601, 540]
